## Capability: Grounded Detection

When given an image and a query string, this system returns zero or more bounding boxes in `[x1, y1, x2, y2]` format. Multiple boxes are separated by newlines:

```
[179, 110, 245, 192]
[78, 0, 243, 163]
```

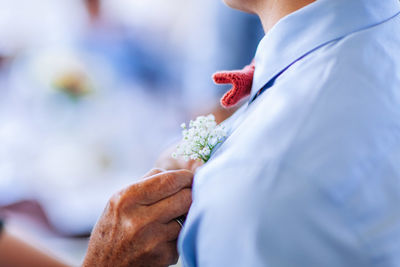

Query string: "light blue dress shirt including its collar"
[179, 0, 400, 267]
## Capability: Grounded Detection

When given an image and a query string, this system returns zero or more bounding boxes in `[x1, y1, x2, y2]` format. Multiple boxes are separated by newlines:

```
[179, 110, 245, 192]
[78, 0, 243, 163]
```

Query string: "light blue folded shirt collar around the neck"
[250, 0, 400, 99]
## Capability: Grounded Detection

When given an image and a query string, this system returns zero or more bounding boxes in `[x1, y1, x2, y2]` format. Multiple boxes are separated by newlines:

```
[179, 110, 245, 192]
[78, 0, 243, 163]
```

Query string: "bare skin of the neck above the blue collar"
[256, 0, 316, 33]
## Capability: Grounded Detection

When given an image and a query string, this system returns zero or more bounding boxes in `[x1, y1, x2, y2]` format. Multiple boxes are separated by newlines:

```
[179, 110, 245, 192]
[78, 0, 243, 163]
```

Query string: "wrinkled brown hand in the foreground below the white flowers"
[83, 169, 193, 267]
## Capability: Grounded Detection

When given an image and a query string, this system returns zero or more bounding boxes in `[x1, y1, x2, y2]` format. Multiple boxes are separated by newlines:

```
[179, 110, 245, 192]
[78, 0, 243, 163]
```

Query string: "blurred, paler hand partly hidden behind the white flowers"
[155, 145, 203, 172]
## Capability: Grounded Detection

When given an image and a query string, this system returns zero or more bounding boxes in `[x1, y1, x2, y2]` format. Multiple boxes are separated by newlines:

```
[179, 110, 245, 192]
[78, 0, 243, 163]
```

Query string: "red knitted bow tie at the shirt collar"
[213, 61, 255, 108]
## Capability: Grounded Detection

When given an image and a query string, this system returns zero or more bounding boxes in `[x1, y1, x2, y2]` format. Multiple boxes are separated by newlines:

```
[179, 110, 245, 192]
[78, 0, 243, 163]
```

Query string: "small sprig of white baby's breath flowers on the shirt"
[172, 114, 227, 163]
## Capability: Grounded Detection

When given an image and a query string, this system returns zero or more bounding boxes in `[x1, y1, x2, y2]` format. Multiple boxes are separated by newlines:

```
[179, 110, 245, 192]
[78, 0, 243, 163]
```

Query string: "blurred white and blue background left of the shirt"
[0, 0, 263, 265]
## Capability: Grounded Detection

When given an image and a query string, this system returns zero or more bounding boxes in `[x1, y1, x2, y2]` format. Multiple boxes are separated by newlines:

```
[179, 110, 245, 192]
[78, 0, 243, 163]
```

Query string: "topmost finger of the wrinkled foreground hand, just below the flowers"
[124, 170, 193, 205]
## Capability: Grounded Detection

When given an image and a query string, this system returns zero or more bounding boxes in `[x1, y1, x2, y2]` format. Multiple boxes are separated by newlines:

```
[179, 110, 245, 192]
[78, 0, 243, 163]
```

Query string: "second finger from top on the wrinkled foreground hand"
[149, 188, 192, 223]
